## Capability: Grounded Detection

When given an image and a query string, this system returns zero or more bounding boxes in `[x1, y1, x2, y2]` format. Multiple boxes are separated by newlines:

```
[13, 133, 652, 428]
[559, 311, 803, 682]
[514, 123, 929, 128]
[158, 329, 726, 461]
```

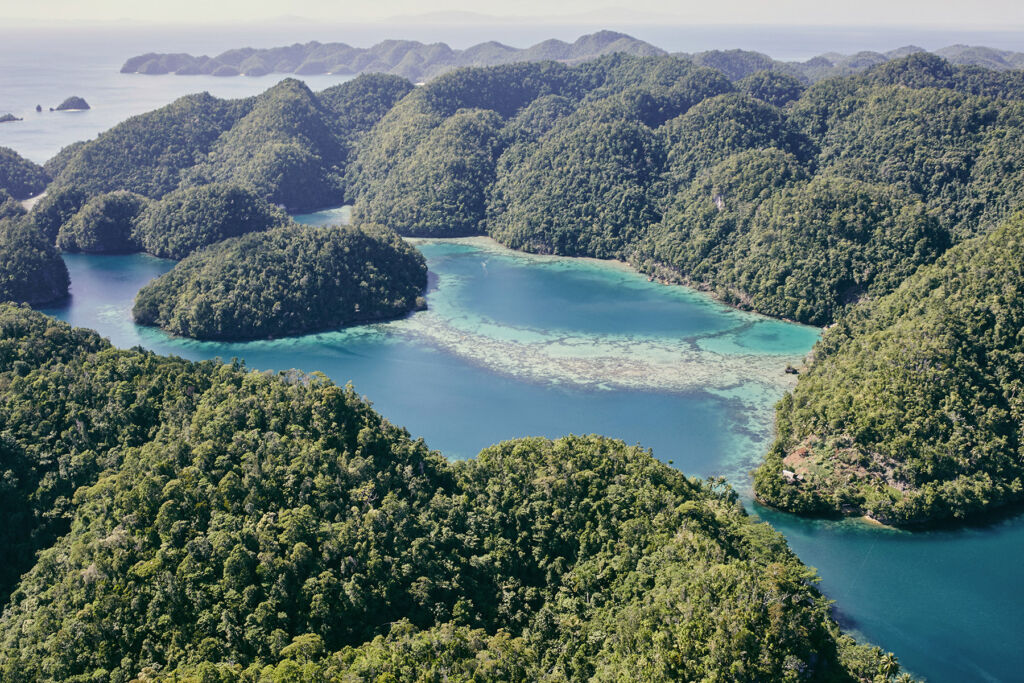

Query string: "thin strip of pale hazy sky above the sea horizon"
[6, 0, 1024, 29]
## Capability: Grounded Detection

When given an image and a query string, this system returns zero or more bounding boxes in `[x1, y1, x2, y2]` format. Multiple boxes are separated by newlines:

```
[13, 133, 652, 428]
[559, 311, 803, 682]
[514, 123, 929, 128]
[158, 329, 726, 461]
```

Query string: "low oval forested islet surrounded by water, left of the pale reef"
[132, 224, 427, 341]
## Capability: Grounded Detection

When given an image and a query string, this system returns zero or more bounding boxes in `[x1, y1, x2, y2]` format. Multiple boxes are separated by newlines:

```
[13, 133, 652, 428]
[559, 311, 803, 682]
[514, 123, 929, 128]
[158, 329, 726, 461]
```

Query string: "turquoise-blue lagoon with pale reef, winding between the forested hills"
[39, 231, 1024, 681]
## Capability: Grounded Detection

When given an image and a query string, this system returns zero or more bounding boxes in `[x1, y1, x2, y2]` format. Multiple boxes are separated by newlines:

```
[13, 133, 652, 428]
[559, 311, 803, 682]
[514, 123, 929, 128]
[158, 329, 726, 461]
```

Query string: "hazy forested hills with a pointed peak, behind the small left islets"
[47, 75, 413, 212]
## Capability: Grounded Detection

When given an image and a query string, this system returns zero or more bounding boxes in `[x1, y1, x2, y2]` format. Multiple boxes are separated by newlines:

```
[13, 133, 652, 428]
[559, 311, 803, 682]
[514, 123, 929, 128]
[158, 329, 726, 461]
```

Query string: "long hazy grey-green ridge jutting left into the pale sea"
[121, 31, 667, 81]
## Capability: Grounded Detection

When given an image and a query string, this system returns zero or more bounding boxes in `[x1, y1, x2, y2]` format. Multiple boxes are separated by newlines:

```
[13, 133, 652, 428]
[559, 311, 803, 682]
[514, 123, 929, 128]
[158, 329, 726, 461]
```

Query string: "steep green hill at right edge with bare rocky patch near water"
[756, 215, 1024, 524]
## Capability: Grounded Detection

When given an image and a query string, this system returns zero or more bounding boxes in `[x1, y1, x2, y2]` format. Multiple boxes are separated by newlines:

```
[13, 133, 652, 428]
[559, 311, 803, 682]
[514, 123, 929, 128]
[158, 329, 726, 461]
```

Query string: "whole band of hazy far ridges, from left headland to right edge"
[121, 31, 1024, 83]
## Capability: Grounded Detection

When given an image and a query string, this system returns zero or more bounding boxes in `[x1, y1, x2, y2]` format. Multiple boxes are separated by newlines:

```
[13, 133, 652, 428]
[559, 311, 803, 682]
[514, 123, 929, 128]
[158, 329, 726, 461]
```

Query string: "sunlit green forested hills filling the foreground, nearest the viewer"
[0, 304, 908, 683]
